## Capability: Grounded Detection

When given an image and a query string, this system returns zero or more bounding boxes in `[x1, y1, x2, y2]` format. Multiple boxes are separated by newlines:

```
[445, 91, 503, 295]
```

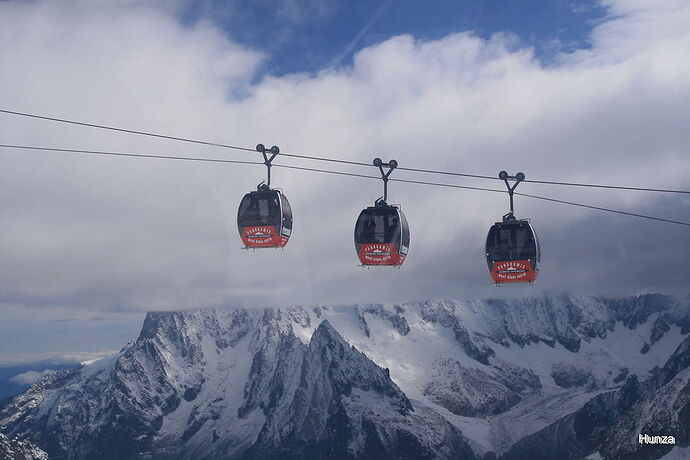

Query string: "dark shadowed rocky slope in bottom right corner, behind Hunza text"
[501, 337, 690, 460]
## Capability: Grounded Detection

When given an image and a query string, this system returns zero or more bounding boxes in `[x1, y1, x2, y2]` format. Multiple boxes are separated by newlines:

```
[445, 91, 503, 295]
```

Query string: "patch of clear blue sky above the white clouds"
[178, 0, 607, 76]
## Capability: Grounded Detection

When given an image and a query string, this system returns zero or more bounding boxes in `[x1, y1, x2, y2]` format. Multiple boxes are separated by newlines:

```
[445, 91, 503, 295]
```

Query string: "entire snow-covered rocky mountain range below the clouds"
[0, 295, 690, 459]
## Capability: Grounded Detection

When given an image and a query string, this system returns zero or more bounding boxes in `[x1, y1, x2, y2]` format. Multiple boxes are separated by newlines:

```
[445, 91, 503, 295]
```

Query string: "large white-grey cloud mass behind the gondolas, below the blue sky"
[0, 2, 690, 316]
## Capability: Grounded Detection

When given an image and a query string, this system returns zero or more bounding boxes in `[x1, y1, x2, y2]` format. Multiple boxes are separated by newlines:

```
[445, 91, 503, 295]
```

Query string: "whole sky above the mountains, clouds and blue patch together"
[0, 0, 690, 362]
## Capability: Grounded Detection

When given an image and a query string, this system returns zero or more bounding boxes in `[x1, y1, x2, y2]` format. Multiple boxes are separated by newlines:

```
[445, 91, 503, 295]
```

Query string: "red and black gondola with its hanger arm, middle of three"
[355, 158, 410, 267]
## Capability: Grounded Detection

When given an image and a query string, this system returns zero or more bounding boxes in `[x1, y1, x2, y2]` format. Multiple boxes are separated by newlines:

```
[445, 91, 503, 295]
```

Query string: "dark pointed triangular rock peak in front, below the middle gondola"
[246, 321, 474, 459]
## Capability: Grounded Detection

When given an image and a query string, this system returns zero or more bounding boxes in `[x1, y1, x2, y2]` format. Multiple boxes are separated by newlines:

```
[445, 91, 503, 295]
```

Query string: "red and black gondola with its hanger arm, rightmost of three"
[486, 171, 541, 284]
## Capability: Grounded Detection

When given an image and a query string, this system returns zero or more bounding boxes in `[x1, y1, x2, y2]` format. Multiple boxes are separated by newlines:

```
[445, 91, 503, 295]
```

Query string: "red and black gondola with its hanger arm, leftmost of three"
[237, 144, 292, 249]
